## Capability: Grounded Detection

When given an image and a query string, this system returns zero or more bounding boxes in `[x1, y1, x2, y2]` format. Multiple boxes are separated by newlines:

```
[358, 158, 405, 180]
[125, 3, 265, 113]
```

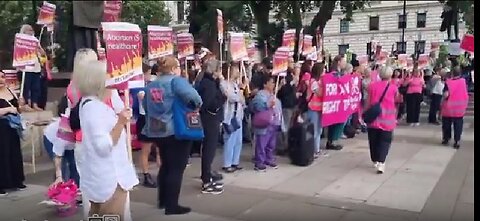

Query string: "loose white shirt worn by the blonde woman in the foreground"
[77, 97, 138, 203]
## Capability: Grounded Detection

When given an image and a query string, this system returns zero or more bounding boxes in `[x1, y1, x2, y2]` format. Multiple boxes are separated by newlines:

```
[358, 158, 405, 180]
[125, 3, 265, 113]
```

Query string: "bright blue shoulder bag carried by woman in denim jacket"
[172, 79, 205, 141]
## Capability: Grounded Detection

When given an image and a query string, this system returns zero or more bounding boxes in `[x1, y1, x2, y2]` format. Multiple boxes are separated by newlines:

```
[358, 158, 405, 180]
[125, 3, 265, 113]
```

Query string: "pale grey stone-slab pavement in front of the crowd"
[0, 116, 474, 221]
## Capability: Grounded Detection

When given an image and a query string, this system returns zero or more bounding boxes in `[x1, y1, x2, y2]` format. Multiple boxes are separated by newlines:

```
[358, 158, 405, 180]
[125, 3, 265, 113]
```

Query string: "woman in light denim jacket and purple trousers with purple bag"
[251, 75, 285, 172]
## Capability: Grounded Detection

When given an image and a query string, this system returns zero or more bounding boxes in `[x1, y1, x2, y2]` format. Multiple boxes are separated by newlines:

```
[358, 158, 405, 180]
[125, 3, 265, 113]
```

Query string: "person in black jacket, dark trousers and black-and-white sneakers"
[197, 59, 226, 194]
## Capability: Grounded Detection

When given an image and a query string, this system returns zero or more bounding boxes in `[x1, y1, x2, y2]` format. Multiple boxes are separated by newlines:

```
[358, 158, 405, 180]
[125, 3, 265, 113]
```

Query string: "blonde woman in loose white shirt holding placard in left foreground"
[74, 61, 138, 220]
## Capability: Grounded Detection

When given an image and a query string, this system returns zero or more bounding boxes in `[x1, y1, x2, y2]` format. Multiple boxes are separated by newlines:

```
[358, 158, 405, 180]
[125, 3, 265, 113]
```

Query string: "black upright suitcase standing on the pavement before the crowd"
[288, 122, 315, 167]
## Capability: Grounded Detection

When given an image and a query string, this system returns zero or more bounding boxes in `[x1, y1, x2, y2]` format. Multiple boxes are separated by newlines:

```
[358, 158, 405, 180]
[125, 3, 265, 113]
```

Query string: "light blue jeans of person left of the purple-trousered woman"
[223, 127, 243, 167]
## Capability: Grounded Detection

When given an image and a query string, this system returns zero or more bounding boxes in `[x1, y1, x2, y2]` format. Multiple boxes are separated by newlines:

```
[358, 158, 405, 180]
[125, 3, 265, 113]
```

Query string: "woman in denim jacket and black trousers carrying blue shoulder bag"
[142, 56, 202, 215]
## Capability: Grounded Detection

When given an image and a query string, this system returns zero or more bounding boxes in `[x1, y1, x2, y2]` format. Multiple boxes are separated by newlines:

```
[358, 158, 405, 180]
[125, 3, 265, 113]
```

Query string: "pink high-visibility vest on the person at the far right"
[441, 78, 468, 117]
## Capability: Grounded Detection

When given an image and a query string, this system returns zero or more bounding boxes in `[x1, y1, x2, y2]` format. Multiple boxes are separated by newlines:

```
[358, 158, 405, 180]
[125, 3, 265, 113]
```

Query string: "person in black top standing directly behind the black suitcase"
[277, 64, 300, 155]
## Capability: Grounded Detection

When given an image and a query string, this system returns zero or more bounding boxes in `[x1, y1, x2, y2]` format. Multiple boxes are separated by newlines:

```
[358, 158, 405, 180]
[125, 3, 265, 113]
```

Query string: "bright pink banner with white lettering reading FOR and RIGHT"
[322, 73, 361, 127]
